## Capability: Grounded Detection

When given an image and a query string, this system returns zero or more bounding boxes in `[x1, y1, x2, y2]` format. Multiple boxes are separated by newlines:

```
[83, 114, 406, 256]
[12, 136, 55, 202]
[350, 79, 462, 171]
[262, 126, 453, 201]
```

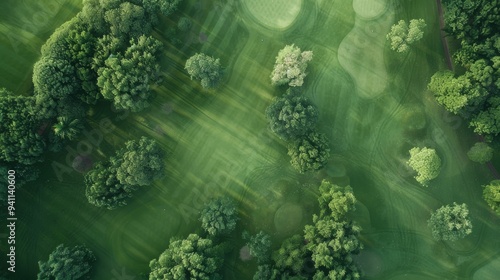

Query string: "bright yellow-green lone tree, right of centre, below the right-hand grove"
[407, 147, 441, 186]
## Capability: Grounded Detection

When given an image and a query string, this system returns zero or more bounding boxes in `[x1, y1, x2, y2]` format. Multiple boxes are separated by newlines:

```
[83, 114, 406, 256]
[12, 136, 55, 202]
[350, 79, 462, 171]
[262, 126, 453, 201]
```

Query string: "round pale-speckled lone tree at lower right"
[427, 202, 472, 241]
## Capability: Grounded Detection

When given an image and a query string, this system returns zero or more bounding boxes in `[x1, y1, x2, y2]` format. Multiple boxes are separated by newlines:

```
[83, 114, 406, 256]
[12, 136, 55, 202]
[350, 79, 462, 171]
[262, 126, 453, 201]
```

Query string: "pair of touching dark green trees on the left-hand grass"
[85, 137, 164, 210]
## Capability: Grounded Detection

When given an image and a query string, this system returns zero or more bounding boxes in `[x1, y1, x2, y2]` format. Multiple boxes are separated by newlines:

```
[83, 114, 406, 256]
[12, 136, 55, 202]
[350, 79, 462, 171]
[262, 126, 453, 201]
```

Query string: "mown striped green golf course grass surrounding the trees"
[0, 0, 500, 280]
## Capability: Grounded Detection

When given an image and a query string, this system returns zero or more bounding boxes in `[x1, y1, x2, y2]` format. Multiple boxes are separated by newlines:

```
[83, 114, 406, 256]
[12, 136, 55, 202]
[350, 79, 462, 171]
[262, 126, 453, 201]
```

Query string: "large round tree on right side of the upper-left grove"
[97, 36, 162, 112]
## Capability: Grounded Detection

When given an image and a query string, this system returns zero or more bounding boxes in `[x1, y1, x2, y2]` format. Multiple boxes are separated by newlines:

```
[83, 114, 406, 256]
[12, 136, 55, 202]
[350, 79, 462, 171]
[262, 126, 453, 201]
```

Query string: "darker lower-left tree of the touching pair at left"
[85, 161, 138, 210]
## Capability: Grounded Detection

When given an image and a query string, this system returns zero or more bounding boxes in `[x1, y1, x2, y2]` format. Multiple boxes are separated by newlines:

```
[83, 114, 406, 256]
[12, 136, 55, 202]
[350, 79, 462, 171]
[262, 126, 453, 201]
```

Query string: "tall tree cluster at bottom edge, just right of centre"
[253, 181, 363, 280]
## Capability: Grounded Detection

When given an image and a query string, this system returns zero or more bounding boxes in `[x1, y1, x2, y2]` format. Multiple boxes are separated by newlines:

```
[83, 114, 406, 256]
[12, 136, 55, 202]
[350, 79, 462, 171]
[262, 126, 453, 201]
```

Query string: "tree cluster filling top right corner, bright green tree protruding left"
[428, 0, 500, 139]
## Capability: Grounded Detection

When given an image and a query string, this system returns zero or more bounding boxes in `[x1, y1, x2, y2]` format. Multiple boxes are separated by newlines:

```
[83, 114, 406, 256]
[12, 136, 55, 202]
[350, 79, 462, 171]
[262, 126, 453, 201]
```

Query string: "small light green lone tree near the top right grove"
[386, 19, 426, 53]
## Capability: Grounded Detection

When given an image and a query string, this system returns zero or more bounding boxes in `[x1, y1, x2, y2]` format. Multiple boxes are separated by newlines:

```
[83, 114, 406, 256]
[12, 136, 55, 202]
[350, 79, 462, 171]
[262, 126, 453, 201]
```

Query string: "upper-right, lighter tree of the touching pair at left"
[116, 137, 165, 186]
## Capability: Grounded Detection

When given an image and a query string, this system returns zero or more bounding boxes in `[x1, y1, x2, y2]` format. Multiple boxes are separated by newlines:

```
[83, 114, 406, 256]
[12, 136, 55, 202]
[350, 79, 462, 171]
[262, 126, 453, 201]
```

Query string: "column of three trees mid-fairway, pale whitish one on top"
[266, 45, 330, 173]
